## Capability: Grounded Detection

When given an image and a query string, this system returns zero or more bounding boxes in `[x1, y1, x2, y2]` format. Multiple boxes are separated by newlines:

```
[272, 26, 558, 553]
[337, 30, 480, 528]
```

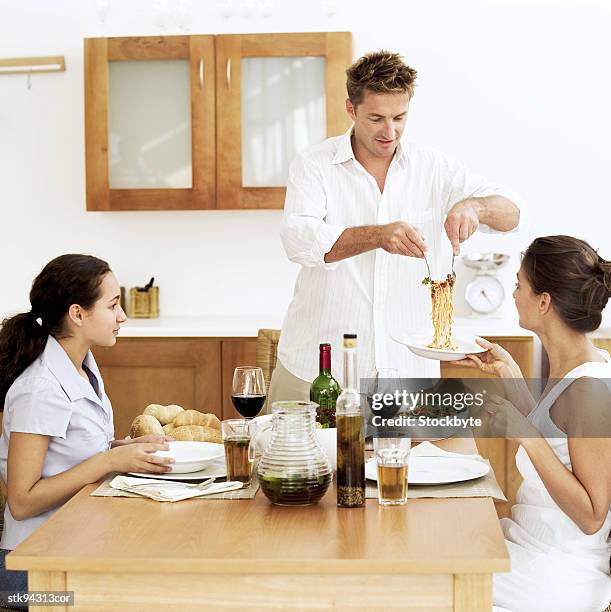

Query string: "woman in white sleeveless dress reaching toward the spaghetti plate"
[456, 236, 611, 612]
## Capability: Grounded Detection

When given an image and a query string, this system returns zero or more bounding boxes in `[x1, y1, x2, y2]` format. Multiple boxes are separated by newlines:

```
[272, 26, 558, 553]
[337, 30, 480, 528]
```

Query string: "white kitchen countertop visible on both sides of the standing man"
[119, 314, 533, 338]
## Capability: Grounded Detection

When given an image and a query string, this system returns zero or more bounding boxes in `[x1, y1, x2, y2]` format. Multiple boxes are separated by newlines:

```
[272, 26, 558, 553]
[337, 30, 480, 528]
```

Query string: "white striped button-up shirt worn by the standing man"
[278, 130, 524, 383]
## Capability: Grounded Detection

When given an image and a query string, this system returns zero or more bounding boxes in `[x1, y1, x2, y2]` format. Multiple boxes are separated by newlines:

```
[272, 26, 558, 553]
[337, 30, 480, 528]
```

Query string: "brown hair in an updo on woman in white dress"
[522, 236, 611, 333]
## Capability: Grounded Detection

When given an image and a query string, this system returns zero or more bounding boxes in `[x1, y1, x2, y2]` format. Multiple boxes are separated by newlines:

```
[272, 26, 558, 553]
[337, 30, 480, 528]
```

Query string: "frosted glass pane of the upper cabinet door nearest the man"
[242, 57, 327, 187]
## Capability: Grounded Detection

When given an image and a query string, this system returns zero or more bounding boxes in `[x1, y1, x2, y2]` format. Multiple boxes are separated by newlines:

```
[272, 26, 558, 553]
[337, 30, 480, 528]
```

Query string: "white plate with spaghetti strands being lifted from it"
[393, 274, 486, 361]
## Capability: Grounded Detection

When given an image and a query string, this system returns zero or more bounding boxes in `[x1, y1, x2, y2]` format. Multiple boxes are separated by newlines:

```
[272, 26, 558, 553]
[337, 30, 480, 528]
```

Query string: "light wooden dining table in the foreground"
[6, 439, 510, 612]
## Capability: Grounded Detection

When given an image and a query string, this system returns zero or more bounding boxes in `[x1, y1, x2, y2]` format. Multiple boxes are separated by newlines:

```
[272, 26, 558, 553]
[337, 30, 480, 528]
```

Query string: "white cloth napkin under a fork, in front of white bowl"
[110, 476, 243, 502]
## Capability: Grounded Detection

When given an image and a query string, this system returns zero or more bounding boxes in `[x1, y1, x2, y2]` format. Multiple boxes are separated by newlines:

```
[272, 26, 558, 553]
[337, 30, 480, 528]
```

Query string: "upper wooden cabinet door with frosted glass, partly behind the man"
[215, 32, 352, 208]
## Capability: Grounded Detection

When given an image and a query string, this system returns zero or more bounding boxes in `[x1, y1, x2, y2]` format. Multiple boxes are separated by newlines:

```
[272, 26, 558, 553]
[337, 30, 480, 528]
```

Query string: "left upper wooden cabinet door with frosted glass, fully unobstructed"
[84, 35, 216, 211]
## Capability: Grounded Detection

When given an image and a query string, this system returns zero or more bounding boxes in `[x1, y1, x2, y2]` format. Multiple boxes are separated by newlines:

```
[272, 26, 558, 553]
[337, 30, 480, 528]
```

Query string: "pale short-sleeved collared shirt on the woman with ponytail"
[0, 336, 114, 550]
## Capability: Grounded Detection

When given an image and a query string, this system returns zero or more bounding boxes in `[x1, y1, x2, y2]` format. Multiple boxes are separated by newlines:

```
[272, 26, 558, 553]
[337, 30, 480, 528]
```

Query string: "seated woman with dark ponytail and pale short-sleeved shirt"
[0, 255, 177, 604]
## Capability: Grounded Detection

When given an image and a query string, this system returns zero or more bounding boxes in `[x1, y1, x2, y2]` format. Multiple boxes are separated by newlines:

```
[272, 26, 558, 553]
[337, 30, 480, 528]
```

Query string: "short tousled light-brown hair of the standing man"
[346, 50, 418, 107]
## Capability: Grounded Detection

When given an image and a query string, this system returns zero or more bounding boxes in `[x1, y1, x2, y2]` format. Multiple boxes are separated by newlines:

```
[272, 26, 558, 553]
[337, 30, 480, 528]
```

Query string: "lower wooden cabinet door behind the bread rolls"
[94, 338, 222, 438]
